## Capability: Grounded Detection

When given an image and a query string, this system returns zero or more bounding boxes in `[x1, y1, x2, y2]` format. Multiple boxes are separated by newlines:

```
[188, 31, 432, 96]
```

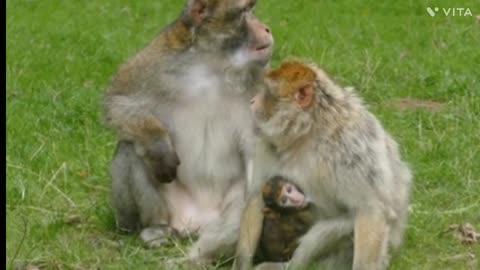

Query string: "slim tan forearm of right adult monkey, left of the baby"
[234, 193, 263, 270]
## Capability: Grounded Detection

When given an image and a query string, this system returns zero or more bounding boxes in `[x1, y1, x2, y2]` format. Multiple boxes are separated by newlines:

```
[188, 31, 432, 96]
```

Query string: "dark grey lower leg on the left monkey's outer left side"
[110, 142, 141, 232]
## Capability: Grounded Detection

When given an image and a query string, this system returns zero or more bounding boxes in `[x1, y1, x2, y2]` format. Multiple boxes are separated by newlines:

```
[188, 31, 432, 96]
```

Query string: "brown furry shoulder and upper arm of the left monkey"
[103, 38, 181, 142]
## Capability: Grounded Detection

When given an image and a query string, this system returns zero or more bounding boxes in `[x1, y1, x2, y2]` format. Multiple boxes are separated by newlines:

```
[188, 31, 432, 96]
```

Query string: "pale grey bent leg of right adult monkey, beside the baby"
[288, 216, 354, 270]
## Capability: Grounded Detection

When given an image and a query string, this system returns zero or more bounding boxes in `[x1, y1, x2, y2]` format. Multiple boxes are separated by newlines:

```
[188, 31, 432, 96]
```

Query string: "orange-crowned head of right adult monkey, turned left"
[250, 62, 316, 146]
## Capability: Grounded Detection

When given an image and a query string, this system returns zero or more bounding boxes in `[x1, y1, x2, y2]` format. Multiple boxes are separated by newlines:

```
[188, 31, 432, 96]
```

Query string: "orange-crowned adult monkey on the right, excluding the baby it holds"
[236, 61, 411, 270]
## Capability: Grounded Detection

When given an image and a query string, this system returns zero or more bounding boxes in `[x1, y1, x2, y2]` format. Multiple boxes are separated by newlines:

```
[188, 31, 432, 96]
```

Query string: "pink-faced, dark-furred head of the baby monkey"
[262, 176, 308, 210]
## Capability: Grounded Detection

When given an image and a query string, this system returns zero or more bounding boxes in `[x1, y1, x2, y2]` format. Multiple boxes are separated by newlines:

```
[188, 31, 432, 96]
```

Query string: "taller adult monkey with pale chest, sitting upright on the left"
[104, 0, 273, 259]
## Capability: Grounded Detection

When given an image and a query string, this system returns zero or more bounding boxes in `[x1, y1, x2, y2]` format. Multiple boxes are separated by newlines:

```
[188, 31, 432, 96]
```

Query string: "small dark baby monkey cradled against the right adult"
[254, 176, 314, 263]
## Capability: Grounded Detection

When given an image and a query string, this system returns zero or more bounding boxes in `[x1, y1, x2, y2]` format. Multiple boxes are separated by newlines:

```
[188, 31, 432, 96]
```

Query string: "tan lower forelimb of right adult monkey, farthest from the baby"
[353, 207, 389, 270]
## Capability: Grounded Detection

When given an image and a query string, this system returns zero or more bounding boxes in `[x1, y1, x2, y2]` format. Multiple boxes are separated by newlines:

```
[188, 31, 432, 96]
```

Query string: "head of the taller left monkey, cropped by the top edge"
[191, 0, 274, 66]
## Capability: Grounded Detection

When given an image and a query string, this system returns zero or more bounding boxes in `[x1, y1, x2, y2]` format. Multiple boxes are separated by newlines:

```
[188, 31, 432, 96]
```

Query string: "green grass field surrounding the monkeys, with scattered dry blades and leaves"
[6, 0, 480, 269]
